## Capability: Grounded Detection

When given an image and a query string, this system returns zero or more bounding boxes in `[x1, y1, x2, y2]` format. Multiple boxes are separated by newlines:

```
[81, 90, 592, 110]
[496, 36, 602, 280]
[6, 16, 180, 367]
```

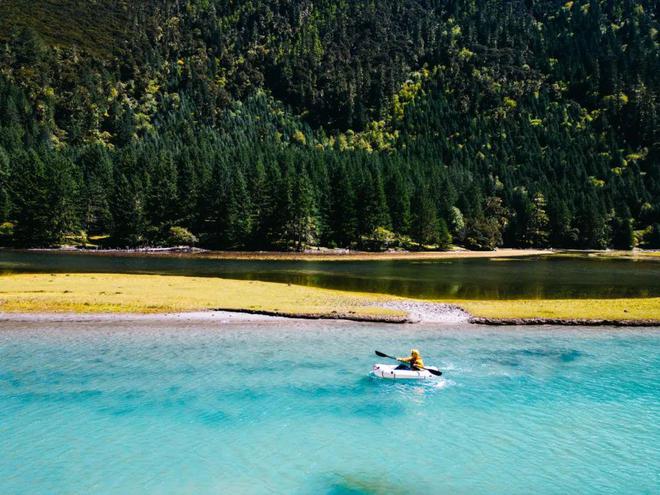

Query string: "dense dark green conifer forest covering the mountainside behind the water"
[0, 0, 660, 250]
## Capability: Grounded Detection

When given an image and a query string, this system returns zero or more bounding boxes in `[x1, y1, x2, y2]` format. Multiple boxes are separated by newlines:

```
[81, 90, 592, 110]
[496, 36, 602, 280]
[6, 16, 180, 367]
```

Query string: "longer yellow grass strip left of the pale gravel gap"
[0, 274, 405, 319]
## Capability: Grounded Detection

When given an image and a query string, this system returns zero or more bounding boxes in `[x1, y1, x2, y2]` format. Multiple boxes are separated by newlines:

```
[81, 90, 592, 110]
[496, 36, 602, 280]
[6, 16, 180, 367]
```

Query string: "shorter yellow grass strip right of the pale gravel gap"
[450, 297, 660, 320]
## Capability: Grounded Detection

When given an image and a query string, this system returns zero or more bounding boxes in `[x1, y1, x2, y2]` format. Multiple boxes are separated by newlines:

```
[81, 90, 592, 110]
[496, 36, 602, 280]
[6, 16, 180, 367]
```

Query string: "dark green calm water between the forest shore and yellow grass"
[0, 251, 660, 299]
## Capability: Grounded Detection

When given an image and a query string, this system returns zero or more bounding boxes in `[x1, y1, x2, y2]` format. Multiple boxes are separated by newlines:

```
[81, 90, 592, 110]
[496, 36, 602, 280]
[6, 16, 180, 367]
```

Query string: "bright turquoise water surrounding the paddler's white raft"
[0, 320, 660, 495]
